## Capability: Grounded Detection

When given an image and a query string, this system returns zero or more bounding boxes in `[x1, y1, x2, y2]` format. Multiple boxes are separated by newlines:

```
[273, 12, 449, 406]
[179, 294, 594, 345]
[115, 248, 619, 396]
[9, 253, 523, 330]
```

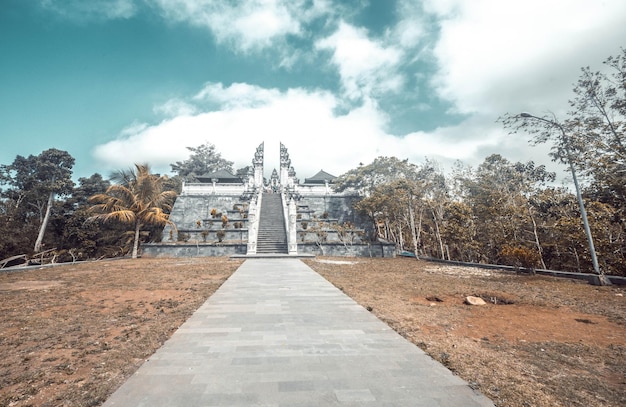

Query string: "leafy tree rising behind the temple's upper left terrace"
[170, 143, 233, 181]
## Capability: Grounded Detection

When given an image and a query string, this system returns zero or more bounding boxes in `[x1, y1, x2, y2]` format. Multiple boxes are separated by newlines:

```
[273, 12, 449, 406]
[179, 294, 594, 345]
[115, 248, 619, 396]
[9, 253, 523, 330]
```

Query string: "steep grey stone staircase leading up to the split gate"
[256, 193, 288, 254]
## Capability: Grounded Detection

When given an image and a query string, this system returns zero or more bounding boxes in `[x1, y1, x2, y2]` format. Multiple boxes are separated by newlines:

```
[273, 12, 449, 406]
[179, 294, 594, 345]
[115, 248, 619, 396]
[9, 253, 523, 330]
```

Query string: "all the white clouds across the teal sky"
[86, 0, 626, 183]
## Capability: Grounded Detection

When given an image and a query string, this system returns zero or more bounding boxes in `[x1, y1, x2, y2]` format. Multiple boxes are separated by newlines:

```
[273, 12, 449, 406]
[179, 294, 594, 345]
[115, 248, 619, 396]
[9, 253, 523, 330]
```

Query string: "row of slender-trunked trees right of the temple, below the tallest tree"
[342, 150, 626, 274]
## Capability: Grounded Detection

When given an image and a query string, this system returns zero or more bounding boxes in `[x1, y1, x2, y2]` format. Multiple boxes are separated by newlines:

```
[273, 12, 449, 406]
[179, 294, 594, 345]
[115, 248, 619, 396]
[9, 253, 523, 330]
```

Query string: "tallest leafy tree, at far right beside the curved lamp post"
[500, 49, 626, 274]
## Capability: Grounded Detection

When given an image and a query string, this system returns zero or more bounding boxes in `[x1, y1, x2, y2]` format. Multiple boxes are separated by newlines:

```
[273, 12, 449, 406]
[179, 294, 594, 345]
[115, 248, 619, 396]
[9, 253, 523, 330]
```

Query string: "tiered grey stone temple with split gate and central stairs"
[143, 143, 395, 257]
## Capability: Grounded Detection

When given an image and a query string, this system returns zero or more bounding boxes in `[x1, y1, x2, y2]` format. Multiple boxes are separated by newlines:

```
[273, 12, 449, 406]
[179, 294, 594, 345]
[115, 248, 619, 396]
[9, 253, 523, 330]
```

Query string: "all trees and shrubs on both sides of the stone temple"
[0, 50, 626, 275]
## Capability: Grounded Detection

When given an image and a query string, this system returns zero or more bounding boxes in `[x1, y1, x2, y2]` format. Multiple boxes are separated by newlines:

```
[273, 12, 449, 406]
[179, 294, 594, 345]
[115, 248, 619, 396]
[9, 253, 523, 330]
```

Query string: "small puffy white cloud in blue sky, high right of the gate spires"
[315, 21, 404, 99]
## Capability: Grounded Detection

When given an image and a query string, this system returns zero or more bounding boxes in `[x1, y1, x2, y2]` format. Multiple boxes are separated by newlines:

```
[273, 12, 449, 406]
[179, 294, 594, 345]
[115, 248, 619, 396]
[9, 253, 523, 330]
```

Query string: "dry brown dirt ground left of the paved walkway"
[0, 258, 241, 407]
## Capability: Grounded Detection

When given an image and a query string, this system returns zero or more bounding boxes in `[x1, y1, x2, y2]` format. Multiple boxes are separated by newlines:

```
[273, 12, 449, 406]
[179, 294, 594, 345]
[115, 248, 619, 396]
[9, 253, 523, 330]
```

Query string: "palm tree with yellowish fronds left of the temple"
[89, 164, 176, 259]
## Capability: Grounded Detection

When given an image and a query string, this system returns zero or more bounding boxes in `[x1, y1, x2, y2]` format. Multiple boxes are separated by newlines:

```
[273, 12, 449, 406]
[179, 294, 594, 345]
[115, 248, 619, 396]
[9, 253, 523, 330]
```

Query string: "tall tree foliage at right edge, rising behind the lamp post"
[500, 49, 626, 273]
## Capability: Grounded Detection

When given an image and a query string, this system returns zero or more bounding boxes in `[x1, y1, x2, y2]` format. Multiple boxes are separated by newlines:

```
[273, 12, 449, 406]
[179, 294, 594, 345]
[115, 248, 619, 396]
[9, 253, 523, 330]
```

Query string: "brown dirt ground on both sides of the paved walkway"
[0, 258, 626, 406]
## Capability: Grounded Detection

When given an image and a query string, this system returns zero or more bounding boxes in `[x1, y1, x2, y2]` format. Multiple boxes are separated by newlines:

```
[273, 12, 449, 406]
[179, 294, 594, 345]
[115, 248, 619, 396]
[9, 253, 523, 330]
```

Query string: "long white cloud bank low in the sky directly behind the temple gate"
[94, 84, 502, 179]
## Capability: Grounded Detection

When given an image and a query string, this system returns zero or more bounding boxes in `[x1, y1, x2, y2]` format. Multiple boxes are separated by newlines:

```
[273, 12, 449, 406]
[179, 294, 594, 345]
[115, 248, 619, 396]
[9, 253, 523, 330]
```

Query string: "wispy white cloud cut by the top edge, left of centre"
[153, 0, 331, 52]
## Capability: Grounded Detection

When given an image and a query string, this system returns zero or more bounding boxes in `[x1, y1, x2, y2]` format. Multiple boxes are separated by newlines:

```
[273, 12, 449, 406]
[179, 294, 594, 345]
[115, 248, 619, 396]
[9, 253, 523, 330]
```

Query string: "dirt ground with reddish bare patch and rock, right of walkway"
[307, 258, 626, 407]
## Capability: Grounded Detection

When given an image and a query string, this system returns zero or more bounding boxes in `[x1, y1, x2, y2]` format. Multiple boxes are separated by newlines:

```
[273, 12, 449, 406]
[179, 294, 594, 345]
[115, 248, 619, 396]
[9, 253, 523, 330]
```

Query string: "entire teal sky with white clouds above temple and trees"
[0, 0, 626, 179]
